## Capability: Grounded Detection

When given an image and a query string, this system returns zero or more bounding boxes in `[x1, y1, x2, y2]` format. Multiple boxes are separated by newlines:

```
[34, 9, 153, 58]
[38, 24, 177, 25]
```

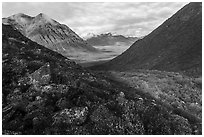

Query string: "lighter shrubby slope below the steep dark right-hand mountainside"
[103, 70, 202, 118]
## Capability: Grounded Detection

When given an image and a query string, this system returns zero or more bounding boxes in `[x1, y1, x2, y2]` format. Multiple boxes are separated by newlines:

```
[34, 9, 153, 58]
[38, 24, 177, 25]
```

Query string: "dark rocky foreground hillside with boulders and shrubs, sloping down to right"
[2, 25, 202, 135]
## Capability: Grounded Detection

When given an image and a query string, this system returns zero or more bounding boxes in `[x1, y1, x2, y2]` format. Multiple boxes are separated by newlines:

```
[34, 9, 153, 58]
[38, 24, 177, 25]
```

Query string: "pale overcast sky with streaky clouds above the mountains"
[2, 2, 187, 37]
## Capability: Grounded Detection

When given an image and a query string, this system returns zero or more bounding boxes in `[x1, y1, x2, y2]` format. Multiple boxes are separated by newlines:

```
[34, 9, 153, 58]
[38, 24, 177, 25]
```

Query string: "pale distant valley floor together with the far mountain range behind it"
[75, 33, 137, 67]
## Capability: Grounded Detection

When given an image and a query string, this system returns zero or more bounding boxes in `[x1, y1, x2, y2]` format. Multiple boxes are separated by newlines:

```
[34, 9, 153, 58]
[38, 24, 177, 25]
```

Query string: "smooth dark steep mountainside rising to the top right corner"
[95, 3, 202, 76]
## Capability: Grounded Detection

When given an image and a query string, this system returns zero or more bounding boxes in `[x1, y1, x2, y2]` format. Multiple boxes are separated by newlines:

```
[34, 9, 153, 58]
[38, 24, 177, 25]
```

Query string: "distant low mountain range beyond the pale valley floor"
[86, 33, 139, 46]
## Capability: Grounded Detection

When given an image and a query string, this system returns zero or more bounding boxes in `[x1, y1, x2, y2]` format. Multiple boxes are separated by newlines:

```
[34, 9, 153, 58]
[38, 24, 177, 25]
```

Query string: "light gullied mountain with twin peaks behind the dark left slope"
[2, 13, 96, 56]
